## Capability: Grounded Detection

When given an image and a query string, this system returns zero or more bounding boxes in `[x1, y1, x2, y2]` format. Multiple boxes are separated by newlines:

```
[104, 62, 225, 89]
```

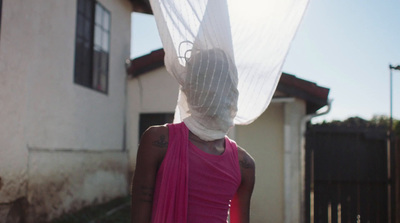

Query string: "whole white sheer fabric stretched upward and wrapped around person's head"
[150, 0, 308, 140]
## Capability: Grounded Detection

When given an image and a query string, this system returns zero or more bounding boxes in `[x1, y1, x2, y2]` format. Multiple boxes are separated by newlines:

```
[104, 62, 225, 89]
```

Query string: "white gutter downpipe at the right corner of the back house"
[300, 99, 332, 223]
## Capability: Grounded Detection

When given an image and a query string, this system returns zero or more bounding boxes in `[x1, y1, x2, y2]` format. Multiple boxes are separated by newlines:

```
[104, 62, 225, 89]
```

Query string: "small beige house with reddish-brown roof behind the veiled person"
[127, 49, 329, 223]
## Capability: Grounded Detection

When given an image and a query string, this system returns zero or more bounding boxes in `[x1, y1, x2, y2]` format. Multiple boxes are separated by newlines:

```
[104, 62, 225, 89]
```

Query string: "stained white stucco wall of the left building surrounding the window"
[0, 0, 132, 219]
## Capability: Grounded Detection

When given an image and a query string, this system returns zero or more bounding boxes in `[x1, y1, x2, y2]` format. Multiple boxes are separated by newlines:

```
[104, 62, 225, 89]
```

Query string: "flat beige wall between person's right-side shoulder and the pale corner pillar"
[235, 103, 284, 223]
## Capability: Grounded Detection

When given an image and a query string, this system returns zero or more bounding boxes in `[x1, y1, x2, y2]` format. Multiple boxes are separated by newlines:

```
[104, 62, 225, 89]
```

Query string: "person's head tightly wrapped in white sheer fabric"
[180, 49, 238, 140]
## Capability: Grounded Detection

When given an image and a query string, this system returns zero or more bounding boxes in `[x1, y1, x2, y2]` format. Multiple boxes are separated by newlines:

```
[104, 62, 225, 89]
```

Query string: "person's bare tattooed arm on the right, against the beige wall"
[230, 147, 255, 223]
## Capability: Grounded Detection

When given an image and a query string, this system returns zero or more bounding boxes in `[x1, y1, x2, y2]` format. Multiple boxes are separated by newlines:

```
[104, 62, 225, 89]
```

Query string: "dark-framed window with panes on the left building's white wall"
[74, 0, 111, 95]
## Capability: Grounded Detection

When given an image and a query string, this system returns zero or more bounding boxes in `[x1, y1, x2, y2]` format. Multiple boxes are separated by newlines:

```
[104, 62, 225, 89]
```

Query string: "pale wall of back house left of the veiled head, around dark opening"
[127, 67, 179, 171]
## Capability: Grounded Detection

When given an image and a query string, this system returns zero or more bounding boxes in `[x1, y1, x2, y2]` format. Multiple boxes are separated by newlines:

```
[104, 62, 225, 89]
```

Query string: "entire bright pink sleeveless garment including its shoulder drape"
[152, 122, 241, 223]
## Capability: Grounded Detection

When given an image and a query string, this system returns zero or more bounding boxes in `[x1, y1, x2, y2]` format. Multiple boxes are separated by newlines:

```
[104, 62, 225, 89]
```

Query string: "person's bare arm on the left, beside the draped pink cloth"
[131, 126, 168, 223]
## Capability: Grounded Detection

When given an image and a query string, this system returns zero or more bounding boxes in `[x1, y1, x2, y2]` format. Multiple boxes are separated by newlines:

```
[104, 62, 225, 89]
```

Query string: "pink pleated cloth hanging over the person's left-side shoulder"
[151, 123, 189, 223]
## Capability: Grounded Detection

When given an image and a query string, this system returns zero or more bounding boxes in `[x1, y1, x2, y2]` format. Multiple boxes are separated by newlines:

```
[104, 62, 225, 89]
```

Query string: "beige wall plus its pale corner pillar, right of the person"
[235, 98, 306, 223]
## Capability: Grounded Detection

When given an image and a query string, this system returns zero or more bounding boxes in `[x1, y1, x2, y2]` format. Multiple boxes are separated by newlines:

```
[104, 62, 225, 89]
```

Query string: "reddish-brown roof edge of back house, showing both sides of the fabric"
[127, 49, 329, 114]
